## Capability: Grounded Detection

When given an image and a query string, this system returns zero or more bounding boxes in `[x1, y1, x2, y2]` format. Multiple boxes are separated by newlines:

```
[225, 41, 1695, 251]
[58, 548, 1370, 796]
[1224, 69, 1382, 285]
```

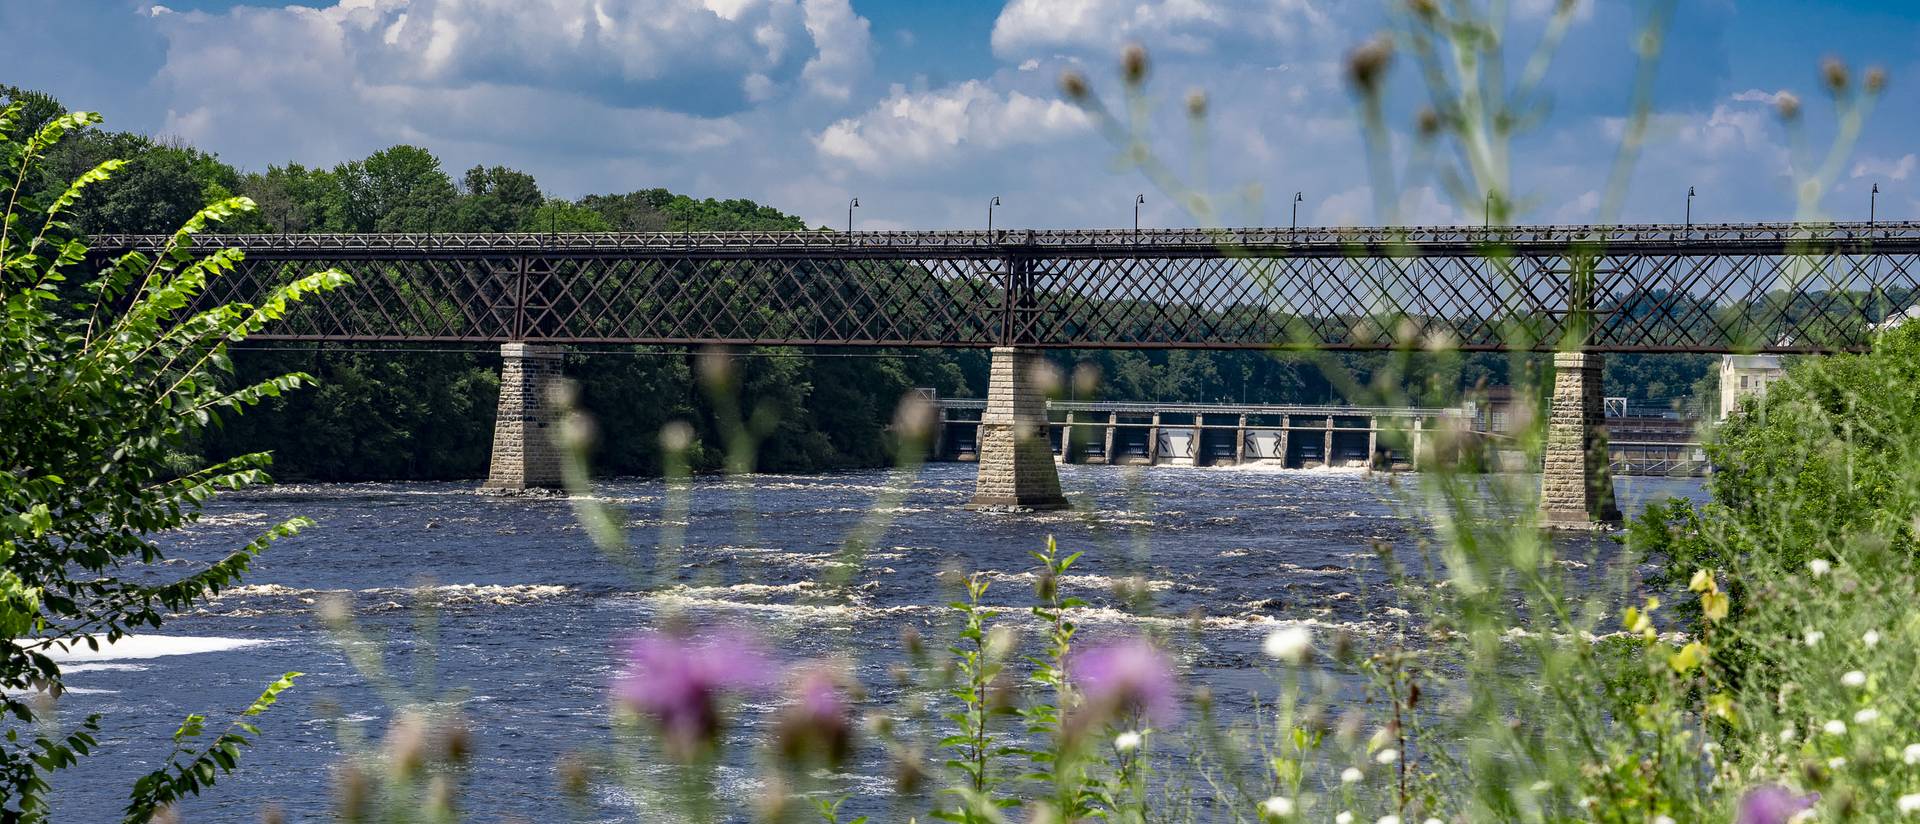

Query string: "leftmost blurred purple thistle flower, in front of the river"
[614, 632, 772, 761]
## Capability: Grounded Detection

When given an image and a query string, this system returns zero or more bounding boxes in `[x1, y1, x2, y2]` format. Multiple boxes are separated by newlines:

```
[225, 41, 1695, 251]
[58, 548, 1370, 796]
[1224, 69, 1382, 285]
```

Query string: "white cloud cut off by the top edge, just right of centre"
[993, 0, 1325, 58]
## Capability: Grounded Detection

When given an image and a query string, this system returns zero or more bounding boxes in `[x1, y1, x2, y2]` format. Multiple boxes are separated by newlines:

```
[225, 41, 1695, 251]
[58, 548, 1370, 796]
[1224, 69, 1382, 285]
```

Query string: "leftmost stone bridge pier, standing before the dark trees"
[480, 344, 561, 494]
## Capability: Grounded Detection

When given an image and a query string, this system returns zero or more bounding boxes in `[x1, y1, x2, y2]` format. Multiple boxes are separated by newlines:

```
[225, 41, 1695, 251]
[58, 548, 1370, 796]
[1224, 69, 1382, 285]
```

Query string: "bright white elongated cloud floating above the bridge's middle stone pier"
[814, 81, 1091, 173]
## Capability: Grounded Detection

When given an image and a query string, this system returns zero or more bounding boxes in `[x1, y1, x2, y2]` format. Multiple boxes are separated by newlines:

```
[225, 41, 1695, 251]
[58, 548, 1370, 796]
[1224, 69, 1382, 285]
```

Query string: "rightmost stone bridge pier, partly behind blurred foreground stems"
[1540, 351, 1620, 530]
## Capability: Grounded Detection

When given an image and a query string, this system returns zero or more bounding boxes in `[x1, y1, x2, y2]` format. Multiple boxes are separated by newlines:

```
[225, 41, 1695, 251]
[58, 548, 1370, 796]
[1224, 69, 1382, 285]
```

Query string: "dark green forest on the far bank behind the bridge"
[0, 86, 1711, 480]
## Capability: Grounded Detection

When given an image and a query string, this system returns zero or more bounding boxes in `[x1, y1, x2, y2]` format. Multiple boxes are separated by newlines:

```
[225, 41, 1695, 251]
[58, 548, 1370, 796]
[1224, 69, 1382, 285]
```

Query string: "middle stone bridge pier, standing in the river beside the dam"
[968, 346, 1068, 509]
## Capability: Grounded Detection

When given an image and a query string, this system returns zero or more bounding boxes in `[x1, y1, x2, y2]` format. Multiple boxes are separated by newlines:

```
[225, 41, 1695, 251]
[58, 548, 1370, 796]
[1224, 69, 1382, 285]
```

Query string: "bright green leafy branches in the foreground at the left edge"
[0, 104, 334, 822]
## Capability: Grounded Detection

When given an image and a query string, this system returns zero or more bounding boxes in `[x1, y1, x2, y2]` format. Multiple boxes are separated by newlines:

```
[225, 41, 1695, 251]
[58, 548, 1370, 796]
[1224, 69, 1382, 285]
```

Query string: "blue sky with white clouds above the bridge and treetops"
[0, 0, 1920, 229]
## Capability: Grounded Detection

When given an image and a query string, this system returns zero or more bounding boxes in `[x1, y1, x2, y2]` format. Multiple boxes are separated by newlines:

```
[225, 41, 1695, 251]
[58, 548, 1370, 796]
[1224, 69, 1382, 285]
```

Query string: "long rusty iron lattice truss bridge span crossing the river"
[92, 223, 1920, 351]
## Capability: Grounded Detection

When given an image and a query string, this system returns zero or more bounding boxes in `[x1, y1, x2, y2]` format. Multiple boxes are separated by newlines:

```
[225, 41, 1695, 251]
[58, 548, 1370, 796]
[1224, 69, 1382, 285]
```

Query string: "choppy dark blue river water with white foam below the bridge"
[45, 465, 1699, 822]
